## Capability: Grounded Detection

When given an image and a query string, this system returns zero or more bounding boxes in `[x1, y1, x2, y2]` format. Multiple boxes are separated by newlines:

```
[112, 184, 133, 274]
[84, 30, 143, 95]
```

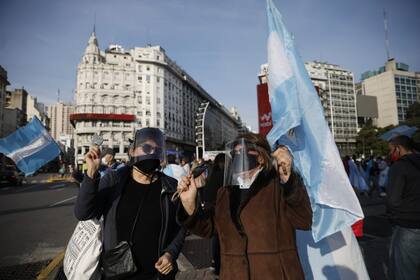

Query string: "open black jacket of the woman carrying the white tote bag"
[74, 166, 186, 275]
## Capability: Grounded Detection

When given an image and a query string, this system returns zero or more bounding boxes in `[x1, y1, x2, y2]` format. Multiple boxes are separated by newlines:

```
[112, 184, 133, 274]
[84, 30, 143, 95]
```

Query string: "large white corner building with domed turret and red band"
[71, 33, 239, 164]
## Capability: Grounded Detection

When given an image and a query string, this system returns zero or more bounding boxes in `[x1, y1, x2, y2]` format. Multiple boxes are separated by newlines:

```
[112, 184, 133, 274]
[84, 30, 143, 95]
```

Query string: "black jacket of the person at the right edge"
[387, 154, 420, 229]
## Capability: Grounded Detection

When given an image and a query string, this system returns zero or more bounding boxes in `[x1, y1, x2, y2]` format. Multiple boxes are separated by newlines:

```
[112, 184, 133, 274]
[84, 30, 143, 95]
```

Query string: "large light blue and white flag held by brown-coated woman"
[267, 0, 368, 279]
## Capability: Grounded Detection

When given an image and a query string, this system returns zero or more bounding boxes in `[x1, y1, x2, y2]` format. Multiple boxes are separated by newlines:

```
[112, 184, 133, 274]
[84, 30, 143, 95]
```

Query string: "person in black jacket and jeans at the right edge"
[387, 135, 420, 280]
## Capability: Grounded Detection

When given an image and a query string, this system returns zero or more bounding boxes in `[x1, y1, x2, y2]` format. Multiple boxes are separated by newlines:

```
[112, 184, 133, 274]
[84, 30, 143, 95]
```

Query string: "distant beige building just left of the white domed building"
[47, 102, 74, 141]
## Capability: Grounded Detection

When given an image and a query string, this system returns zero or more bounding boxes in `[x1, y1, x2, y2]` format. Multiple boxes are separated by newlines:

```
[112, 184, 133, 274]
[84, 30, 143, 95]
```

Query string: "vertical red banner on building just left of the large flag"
[257, 83, 273, 136]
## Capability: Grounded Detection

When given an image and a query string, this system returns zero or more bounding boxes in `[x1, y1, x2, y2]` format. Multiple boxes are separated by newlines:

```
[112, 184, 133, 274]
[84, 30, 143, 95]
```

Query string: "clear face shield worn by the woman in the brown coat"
[224, 138, 262, 189]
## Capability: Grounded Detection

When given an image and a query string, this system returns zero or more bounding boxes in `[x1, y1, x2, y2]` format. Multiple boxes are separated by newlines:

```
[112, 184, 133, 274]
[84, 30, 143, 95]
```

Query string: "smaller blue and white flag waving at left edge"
[0, 117, 60, 176]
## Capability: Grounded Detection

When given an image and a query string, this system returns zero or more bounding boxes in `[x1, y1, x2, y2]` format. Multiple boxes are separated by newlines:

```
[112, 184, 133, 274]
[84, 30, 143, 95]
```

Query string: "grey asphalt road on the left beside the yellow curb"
[0, 177, 77, 279]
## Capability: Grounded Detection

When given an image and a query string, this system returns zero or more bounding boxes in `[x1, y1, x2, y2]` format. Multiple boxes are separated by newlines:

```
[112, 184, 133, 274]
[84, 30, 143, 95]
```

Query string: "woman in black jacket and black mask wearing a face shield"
[75, 128, 185, 279]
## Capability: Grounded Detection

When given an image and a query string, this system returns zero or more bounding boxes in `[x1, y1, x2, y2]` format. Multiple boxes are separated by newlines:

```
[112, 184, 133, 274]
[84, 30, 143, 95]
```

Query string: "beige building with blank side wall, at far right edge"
[361, 59, 420, 127]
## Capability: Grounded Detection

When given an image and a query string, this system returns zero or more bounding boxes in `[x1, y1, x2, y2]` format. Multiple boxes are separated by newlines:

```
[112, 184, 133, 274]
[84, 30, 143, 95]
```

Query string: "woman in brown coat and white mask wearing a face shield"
[178, 133, 312, 280]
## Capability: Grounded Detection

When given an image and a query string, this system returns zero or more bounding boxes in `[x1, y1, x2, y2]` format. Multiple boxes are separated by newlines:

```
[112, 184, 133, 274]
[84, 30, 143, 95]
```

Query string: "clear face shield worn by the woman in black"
[130, 127, 165, 165]
